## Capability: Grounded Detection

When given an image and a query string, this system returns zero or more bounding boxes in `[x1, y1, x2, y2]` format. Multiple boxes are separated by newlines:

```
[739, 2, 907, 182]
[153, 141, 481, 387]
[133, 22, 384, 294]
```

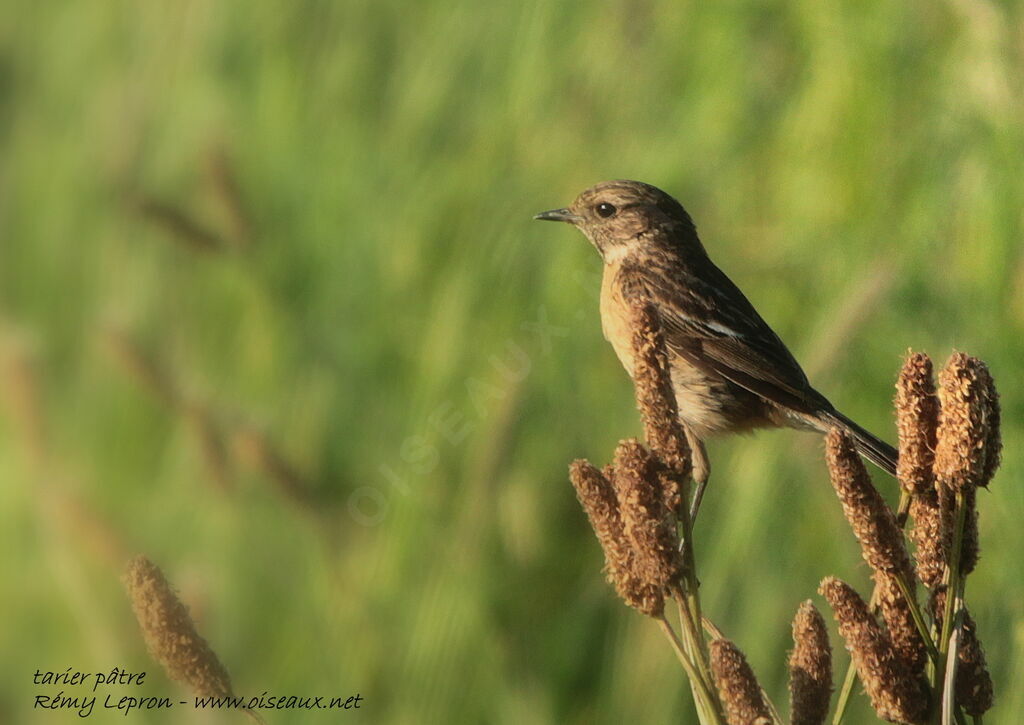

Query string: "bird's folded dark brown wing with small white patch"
[618, 260, 831, 413]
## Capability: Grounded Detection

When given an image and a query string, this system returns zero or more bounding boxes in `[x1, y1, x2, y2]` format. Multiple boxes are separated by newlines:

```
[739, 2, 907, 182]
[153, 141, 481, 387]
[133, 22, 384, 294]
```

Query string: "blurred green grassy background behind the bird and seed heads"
[0, 0, 1024, 725]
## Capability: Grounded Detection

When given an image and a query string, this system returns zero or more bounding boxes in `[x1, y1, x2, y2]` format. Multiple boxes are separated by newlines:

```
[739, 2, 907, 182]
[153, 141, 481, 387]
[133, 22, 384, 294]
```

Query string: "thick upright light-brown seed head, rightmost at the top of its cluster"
[935, 352, 994, 492]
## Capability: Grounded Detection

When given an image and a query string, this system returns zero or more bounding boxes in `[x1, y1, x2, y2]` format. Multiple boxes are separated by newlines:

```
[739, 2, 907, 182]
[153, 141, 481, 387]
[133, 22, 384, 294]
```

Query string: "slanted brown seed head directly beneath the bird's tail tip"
[825, 428, 911, 572]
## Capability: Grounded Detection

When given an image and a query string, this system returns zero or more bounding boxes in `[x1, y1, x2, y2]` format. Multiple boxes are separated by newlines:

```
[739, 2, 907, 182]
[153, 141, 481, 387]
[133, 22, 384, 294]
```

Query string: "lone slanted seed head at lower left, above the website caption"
[124, 556, 232, 696]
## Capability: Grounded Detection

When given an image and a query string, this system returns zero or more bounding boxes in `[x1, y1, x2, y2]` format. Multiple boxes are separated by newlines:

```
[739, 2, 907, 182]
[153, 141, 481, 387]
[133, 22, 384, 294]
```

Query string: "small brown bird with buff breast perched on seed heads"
[534, 181, 897, 516]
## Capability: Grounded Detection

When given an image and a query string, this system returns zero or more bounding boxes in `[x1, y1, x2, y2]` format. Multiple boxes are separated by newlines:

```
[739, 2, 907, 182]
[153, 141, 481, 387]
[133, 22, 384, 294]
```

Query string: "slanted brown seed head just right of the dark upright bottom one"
[818, 577, 928, 723]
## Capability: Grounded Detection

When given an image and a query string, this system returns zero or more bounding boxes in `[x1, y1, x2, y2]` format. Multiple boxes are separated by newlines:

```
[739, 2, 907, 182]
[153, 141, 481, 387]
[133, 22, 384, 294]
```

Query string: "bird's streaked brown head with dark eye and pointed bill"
[534, 181, 702, 264]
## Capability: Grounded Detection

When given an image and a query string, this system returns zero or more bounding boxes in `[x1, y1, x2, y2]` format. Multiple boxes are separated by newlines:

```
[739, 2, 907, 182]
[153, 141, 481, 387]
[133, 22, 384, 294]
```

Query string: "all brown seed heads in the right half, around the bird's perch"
[570, 329, 1001, 725]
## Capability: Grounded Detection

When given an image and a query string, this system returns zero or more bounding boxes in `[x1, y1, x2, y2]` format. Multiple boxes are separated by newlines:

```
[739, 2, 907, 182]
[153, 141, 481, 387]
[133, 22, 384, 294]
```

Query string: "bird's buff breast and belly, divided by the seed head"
[601, 264, 778, 439]
